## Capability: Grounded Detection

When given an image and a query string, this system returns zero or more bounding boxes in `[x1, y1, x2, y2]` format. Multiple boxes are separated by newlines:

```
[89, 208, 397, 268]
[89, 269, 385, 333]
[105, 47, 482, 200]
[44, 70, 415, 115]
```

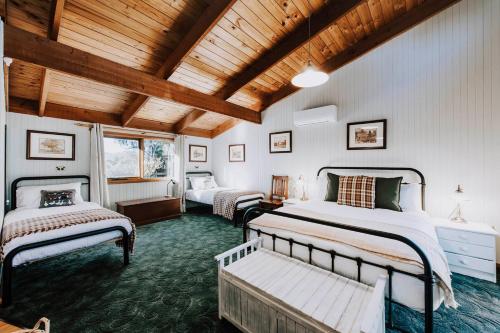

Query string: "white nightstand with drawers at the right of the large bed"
[432, 219, 498, 282]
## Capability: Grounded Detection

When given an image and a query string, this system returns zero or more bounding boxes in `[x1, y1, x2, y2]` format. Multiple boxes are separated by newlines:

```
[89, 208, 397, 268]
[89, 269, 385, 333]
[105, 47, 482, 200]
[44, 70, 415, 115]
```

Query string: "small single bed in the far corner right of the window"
[185, 171, 264, 226]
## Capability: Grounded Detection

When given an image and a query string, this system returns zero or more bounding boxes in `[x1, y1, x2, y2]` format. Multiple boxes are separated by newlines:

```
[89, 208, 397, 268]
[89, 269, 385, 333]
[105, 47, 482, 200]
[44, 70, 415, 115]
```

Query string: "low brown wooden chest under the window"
[116, 197, 181, 225]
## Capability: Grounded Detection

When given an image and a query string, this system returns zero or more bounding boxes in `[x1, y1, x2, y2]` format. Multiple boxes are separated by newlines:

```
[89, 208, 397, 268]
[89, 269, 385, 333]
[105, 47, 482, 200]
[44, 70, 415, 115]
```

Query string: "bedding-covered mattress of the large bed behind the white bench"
[249, 201, 455, 311]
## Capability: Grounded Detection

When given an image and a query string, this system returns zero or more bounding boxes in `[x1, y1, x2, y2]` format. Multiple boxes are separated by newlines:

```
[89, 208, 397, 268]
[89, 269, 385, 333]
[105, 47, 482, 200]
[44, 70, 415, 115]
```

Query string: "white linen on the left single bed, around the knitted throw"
[4, 202, 132, 266]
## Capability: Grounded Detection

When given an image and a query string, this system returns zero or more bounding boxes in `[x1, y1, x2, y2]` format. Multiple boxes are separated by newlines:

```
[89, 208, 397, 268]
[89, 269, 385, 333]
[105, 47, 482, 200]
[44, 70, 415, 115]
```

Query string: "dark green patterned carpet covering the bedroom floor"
[0, 214, 500, 333]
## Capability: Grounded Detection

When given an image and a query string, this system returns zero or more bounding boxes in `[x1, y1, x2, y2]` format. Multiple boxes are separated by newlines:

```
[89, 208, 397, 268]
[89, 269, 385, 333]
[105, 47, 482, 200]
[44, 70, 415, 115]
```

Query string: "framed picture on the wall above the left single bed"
[26, 130, 75, 161]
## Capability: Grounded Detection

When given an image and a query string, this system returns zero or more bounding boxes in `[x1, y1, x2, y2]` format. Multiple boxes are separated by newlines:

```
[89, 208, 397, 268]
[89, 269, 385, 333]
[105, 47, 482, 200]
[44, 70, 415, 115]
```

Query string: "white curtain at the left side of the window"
[90, 124, 110, 208]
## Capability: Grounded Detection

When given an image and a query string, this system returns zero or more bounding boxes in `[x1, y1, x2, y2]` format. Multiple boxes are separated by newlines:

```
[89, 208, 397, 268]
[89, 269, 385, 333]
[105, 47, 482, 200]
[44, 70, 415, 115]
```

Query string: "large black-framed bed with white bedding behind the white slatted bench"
[243, 167, 457, 332]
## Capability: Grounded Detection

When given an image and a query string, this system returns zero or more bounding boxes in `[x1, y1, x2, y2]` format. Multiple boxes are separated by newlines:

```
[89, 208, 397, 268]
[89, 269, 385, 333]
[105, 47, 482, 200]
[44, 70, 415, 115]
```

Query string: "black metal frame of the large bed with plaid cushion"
[243, 167, 436, 333]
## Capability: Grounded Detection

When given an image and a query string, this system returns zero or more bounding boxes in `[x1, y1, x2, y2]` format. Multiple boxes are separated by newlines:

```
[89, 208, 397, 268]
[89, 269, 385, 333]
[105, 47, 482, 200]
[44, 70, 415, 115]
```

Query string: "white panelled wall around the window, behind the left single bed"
[7, 112, 212, 207]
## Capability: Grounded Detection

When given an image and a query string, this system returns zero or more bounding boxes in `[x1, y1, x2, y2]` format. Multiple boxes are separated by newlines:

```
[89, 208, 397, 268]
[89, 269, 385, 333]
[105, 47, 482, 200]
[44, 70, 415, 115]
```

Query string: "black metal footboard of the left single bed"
[1, 226, 130, 307]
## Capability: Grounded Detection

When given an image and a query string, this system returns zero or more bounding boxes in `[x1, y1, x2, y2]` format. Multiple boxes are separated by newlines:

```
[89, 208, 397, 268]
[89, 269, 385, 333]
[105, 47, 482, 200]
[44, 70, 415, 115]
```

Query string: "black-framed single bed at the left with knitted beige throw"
[0, 175, 135, 306]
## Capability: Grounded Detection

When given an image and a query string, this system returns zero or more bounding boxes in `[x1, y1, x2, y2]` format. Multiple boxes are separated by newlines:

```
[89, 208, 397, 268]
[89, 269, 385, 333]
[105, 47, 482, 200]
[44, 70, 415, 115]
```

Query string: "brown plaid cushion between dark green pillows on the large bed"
[337, 176, 375, 209]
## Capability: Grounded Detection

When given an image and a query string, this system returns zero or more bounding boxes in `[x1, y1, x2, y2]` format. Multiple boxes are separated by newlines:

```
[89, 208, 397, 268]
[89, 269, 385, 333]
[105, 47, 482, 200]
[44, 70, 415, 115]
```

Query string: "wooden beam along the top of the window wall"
[9, 96, 173, 133]
